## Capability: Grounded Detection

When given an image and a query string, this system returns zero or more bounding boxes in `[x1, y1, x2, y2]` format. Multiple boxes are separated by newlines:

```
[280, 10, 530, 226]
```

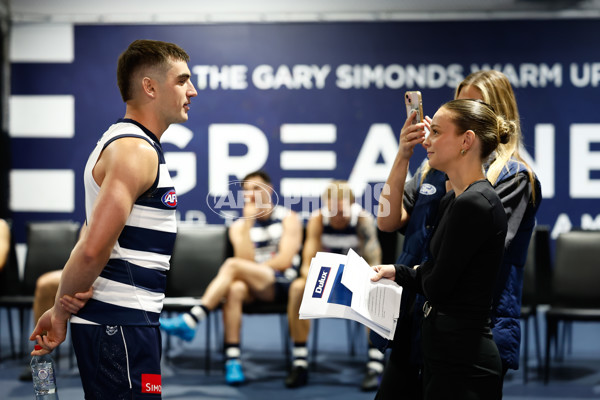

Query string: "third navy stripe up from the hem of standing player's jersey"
[119, 225, 177, 255]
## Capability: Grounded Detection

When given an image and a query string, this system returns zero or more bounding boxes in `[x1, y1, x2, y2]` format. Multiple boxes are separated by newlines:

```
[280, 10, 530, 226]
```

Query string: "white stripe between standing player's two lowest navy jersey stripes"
[92, 276, 165, 313]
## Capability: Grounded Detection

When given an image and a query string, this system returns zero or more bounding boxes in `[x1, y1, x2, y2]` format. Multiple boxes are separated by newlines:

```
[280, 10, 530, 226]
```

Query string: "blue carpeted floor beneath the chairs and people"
[0, 310, 600, 400]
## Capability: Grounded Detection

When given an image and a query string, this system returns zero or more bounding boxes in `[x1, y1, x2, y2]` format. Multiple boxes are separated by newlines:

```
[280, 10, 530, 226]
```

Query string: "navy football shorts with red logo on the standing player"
[71, 324, 162, 400]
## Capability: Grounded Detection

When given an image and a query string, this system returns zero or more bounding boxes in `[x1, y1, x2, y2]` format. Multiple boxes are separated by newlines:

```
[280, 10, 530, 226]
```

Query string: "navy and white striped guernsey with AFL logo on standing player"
[71, 119, 177, 326]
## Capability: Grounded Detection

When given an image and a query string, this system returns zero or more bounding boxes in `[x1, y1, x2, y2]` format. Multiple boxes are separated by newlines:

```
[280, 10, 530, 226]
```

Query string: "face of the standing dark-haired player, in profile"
[158, 60, 198, 125]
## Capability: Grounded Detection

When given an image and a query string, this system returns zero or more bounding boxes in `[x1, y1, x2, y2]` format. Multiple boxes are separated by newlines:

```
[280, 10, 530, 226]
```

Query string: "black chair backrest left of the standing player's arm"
[23, 221, 81, 295]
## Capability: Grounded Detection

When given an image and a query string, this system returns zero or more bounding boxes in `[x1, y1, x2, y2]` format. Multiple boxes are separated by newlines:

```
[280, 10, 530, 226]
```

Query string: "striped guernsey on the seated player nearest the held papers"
[321, 203, 363, 254]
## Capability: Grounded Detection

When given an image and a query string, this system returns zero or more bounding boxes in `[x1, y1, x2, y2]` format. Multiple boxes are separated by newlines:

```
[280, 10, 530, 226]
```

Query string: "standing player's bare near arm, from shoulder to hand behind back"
[31, 138, 158, 354]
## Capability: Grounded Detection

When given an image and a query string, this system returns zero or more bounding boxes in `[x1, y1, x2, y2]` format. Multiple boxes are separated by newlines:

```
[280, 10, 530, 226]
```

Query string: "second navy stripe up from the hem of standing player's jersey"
[100, 258, 167, 293]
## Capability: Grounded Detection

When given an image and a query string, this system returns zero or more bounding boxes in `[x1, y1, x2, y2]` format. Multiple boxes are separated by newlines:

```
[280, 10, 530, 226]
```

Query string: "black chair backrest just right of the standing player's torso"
[166, 224, 227, 297]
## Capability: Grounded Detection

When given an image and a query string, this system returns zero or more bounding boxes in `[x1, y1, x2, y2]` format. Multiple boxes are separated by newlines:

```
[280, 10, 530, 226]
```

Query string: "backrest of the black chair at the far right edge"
[551, 231, 600, 308]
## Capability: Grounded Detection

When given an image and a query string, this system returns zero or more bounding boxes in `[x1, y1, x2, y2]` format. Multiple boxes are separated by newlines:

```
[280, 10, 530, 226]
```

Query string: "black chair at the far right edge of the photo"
[544, 231, 600, 383]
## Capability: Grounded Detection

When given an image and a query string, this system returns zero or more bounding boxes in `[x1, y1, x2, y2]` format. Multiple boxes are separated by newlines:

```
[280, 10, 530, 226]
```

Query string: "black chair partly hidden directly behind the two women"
[521, 226, 551, 383]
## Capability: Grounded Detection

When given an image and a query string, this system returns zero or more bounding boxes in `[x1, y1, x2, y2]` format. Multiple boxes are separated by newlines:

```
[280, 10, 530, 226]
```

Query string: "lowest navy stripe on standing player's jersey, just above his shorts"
[77, 299, 160, 326]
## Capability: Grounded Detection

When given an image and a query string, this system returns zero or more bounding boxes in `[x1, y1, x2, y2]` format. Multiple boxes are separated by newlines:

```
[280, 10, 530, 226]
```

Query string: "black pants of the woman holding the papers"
[422, 310, 502, 400]
